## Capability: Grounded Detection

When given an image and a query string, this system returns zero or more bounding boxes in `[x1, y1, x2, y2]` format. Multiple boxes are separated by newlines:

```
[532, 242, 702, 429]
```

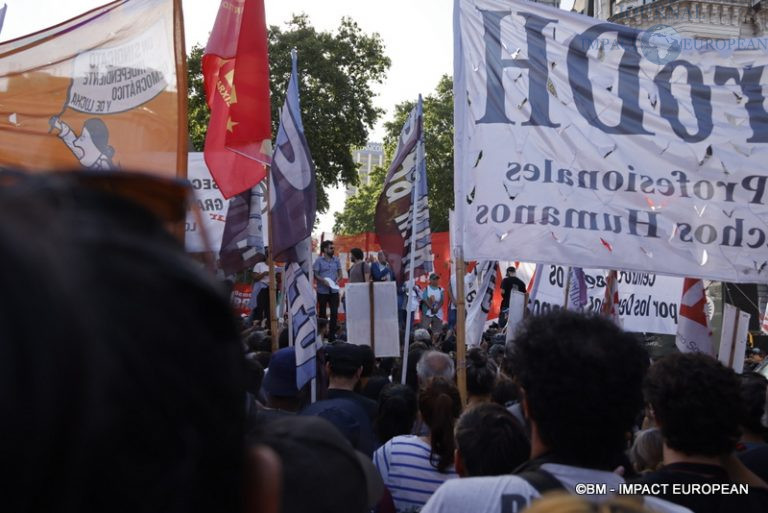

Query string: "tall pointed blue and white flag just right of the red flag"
[269, 49, 317, 271]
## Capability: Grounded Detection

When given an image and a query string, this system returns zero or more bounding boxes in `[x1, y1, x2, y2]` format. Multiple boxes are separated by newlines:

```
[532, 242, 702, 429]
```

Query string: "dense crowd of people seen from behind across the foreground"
[6, 176, 768, 513]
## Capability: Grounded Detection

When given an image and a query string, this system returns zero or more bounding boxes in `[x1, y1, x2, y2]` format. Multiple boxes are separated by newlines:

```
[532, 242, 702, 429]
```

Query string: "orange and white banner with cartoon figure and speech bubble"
[0, 0, 187, 177]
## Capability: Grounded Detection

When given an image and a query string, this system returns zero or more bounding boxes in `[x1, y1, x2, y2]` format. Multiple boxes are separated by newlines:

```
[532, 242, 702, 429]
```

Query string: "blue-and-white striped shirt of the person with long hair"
[373, 435, 458, 513]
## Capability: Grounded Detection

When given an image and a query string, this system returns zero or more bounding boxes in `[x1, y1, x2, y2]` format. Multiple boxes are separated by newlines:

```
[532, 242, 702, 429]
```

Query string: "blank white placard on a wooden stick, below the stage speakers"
[344, 282, 400, 358]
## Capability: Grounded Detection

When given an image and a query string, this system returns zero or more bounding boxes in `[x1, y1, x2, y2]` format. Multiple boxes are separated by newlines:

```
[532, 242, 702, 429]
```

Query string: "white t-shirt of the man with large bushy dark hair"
[421, 463, 691, 513]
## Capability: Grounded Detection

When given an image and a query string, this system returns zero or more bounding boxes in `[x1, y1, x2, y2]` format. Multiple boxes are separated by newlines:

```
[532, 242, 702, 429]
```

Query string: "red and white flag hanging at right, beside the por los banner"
[675, 278, 715, 356]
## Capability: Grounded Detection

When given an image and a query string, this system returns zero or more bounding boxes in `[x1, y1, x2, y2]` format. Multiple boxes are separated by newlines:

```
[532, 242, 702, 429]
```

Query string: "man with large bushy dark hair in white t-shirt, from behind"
[422, 311, 682, 513]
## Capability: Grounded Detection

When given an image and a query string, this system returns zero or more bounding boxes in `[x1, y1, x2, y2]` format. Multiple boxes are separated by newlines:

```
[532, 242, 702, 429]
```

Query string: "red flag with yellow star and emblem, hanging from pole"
[202, 0, 272, 198]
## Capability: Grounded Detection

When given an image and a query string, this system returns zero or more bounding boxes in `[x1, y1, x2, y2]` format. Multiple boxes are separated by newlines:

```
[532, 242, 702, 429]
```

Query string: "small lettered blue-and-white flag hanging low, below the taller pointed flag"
[285, 262, 317, 388]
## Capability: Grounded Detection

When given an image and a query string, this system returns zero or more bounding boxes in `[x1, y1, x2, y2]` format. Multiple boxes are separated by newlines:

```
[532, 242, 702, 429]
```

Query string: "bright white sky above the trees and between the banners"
[0, 0, 571, 231]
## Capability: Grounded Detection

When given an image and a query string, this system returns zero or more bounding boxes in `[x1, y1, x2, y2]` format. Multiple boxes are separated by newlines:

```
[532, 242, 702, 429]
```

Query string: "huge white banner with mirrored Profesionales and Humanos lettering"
[454, 0, 768, 282]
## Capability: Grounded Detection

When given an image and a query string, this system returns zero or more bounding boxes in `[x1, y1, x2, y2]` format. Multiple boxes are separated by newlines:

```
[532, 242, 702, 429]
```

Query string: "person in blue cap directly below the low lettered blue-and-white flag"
[261, 347, 302, 415]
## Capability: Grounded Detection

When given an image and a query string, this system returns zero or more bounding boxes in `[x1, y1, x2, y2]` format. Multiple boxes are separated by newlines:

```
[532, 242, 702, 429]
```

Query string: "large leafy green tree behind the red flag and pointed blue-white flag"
[187, 14, 390, 212]
